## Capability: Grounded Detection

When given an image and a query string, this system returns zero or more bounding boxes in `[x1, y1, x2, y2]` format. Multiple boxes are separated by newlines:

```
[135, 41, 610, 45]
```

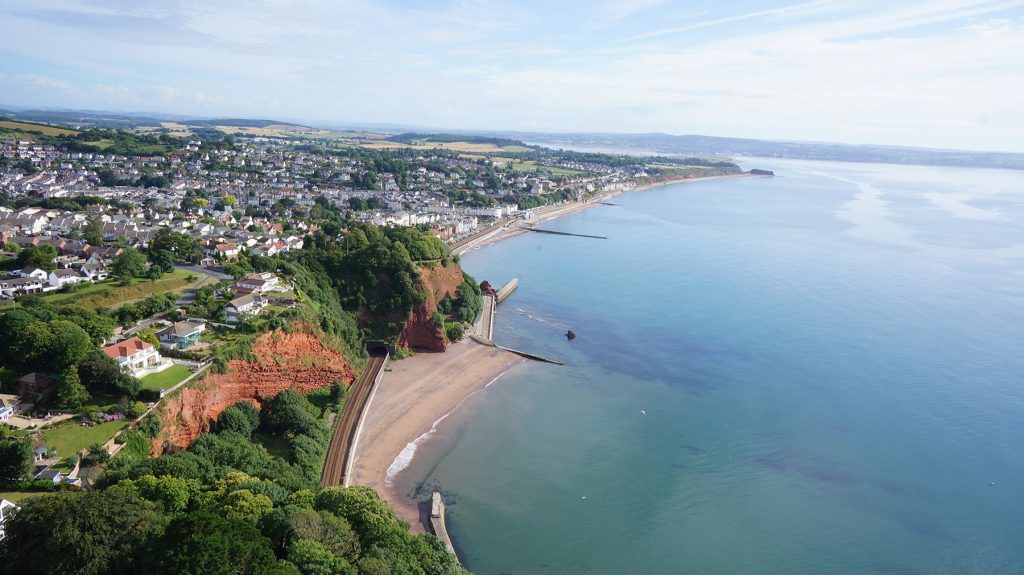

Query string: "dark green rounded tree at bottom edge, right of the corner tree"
[153, 512, 278, 575]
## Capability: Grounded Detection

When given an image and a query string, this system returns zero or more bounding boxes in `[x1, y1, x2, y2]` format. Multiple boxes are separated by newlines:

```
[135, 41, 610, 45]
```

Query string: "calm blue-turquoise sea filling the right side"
[399, 161, 1024, 575]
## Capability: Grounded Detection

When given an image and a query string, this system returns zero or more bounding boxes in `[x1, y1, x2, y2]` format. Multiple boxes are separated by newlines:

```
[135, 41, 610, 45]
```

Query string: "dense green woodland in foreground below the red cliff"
[0, 385, 465, 575]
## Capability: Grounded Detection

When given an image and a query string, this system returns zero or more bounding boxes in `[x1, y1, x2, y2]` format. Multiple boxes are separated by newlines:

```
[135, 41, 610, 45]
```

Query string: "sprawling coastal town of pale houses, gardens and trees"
[0, 115, 738, 536]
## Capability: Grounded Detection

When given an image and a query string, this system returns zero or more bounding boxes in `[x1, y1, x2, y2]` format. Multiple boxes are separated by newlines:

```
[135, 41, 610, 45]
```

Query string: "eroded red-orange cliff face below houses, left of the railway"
[153, 324, 355, 455]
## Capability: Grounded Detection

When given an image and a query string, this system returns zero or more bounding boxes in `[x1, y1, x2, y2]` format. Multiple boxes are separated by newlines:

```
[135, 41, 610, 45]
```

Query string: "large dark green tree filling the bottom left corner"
[0, 487, 164, 575]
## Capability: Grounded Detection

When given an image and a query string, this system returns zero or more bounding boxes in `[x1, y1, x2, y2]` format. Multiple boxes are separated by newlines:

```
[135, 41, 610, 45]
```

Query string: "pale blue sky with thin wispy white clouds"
[0, 0, 1024, 151]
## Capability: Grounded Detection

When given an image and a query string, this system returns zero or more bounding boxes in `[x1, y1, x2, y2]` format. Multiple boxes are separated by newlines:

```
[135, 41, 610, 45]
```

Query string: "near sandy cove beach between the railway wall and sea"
[352, 338, 524, 533]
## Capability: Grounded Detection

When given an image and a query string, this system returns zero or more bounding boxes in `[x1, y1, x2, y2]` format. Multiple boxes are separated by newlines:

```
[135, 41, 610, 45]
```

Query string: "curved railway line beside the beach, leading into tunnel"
[321, 352, 388, 487]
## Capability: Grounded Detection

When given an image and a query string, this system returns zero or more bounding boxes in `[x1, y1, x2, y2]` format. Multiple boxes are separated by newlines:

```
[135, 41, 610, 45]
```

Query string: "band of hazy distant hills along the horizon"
[0, 106, 1024, 170]
